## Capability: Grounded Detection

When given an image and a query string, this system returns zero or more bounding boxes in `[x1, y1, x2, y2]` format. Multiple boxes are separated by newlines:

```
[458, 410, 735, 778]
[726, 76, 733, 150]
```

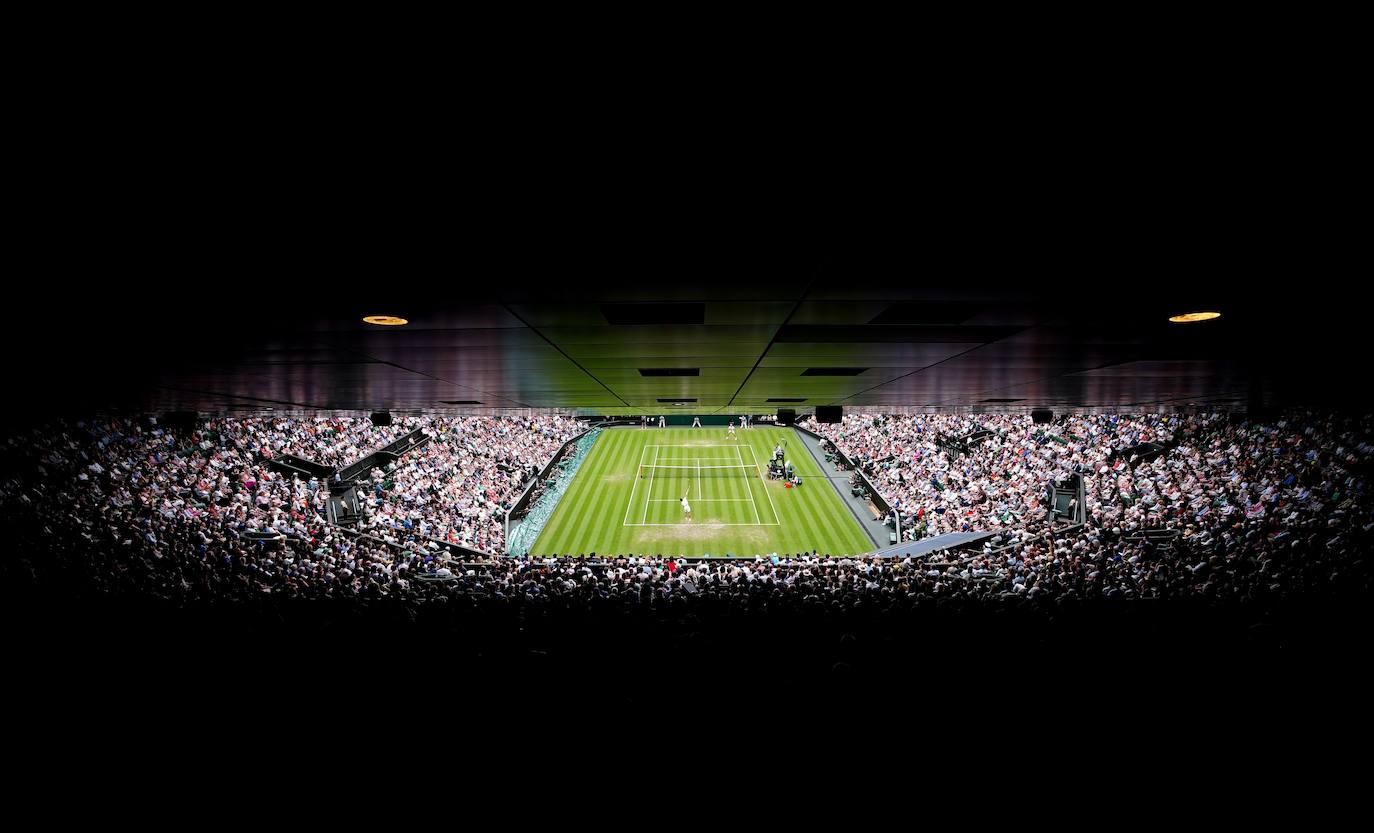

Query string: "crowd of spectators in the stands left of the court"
[0, 417, 576, 598]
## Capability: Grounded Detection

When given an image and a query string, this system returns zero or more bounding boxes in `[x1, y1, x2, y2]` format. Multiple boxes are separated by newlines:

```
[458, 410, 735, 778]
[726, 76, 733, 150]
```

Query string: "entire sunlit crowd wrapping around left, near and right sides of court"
[0, 415, 1374, 624]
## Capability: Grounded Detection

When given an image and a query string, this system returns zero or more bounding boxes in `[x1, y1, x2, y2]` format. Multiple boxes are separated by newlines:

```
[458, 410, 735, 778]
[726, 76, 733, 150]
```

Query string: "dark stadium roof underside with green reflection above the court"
[24, 272, 1367, 414]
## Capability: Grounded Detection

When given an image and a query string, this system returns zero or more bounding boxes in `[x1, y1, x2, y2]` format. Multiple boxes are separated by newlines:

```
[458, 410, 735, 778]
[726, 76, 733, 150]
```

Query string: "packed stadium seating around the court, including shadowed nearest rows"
[0, 414, 1374, 713]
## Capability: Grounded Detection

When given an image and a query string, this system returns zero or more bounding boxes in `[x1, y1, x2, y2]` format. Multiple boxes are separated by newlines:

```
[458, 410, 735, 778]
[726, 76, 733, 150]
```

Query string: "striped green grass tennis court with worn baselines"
[530, 426, 874, 555]
